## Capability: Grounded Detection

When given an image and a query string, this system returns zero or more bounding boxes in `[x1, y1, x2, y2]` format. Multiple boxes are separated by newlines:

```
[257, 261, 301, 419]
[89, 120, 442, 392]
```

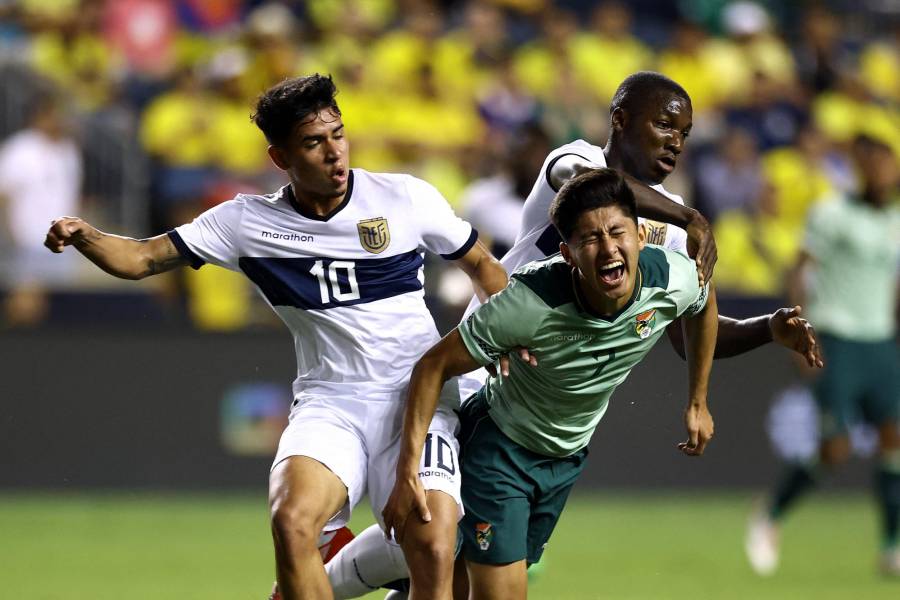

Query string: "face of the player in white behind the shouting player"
[613, 93, 693, 185]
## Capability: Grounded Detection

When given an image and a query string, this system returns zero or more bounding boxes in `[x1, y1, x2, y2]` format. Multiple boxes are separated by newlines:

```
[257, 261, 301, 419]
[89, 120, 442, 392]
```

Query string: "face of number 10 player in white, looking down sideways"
[269, 108, 350, 206]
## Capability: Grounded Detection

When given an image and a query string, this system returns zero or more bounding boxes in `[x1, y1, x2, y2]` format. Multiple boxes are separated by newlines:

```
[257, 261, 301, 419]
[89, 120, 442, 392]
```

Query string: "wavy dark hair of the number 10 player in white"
[251, 73, 341, 146]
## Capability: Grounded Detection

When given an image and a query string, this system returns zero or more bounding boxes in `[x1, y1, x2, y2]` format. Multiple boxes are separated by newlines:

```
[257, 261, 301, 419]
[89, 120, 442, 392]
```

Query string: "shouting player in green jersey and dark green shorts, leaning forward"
[384, 169, 718, 600]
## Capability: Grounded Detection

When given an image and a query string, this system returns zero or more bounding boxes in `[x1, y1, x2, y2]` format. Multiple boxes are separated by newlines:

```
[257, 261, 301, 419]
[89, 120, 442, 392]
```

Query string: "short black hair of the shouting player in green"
[550, 168, 637, 242]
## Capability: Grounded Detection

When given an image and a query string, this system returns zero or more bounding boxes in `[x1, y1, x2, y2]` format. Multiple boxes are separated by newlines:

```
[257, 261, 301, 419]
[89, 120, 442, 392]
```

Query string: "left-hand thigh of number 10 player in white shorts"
[269, 402, 367, 529]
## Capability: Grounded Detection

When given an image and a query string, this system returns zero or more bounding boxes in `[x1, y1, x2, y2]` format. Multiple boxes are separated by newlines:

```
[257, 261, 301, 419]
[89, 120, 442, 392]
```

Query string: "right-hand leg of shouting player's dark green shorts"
[526, 448, 588, 565]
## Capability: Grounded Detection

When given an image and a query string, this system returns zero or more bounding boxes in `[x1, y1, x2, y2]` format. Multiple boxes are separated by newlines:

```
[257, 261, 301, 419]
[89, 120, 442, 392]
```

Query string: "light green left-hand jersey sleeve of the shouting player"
[458, 278, 544, 365]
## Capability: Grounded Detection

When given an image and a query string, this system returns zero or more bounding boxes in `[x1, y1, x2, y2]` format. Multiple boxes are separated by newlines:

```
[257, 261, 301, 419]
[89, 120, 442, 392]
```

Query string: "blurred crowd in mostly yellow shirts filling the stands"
[0, 0, 900, 329]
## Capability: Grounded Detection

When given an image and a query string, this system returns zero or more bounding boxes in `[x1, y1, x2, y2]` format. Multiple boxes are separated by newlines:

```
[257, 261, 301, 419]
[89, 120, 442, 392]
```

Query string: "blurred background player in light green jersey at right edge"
[745, 138, 900, 577]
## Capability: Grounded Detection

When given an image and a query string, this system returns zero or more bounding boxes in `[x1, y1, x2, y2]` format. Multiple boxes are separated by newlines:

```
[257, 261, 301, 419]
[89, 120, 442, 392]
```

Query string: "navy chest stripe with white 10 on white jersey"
[238, 250, 424, 310]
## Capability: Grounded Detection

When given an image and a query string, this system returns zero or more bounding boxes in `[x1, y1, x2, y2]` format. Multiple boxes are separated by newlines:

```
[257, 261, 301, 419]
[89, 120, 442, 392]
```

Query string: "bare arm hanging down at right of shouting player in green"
[678, 285, 719, 456]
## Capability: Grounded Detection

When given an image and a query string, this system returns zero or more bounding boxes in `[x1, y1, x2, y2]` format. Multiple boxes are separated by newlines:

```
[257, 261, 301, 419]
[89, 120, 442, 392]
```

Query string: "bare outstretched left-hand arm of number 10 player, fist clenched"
[44, 217, 188, 279]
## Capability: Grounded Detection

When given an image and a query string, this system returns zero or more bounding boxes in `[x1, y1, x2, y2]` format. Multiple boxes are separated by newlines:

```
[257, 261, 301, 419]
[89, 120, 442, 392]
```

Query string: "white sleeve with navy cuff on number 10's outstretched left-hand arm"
[168, 196, 245, 271]
